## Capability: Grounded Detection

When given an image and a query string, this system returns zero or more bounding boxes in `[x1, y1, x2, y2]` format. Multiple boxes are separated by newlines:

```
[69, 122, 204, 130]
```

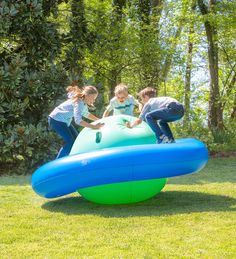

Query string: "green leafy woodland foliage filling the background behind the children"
[0, 0, 236, 175]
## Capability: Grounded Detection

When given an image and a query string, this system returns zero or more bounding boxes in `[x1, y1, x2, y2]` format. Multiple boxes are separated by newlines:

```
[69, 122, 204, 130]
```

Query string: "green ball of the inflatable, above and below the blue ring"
[70, 115, 167, 204]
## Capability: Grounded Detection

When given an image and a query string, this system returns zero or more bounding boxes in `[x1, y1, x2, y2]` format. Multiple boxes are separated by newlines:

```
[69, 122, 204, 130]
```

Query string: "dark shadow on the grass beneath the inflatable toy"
[42, 191, 236, 218]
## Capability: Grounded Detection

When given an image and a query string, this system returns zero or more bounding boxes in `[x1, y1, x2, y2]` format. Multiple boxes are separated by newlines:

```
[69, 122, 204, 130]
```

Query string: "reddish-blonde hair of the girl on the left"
[66, 85, 98, 102]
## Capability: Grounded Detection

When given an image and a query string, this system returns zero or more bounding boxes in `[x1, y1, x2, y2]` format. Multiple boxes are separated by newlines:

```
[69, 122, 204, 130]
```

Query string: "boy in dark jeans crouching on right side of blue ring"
[126, 87, 184, 144]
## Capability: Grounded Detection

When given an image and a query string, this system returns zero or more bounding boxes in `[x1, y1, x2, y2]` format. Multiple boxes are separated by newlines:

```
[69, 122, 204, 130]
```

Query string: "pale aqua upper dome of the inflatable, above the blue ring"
[70, 115, 156, 155]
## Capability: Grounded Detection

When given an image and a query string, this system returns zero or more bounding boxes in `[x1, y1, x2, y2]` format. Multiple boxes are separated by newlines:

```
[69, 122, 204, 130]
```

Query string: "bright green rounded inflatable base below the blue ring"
[78, 178, 167, 205]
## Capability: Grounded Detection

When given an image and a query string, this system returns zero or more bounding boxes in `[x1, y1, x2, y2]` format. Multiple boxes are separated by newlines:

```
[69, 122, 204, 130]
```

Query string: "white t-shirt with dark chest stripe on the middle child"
[106, 95, 138, 116]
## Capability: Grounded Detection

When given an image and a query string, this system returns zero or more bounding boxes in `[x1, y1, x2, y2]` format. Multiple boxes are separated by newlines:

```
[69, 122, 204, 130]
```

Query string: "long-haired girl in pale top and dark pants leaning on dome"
[48, 86, 103, 158]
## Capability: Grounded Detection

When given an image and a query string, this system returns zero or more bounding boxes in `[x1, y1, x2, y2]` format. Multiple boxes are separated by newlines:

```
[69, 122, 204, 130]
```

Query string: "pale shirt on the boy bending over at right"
[139, 96, 179, 120]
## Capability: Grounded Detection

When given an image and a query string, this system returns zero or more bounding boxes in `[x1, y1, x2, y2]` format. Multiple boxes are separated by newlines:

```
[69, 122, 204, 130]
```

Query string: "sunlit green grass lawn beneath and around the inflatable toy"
[0, 158, 236, 259]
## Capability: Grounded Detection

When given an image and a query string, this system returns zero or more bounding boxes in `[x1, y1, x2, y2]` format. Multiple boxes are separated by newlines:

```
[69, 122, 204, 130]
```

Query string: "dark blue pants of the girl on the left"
[48, 117, 78, 158]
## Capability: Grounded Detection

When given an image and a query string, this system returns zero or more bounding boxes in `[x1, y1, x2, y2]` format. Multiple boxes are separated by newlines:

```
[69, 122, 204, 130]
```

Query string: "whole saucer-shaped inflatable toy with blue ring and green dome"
[32, 115, 208, 204]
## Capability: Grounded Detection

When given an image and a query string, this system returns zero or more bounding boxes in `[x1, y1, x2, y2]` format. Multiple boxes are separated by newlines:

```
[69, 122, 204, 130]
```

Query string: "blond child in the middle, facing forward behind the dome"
[103, 84, 141, 117]
